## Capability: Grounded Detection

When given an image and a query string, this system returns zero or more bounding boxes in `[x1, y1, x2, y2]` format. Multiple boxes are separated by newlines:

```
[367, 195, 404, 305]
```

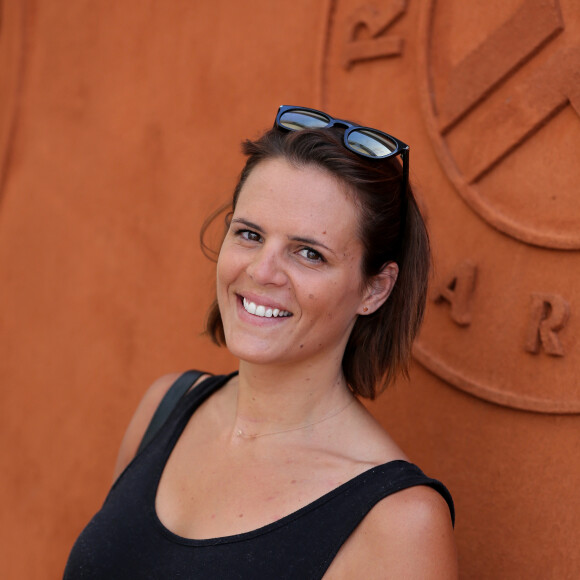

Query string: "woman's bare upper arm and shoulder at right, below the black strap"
[325, 486, 458, 580]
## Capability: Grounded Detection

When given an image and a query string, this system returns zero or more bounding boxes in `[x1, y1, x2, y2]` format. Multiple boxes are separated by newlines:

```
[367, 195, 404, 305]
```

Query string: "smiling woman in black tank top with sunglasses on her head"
[65, 106, 457, 579]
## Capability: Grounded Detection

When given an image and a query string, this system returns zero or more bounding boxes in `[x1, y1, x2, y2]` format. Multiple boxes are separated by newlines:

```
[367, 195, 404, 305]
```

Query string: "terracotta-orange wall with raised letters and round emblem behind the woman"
[0, 0, 580, 579]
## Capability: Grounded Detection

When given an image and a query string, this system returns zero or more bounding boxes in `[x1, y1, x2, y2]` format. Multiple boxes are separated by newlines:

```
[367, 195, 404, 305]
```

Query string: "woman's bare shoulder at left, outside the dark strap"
[113, 373, 206, 481]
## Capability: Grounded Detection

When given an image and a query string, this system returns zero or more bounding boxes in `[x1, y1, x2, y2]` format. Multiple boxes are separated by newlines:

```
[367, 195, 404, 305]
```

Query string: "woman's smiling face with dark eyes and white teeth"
[217, 159, 364, 364]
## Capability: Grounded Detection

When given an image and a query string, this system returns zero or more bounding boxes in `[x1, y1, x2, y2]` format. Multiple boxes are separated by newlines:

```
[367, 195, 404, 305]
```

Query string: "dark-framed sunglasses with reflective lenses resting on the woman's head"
[274, 105, 409, 194]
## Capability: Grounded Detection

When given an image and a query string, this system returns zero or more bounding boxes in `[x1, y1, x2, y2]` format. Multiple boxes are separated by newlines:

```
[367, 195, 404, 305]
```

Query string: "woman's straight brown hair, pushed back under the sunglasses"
[201, 128, 430, 399]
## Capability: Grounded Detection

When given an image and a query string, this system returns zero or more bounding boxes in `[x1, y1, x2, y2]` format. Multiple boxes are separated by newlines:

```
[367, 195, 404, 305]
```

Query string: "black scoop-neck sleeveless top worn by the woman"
[64, 375, 454, 580]
